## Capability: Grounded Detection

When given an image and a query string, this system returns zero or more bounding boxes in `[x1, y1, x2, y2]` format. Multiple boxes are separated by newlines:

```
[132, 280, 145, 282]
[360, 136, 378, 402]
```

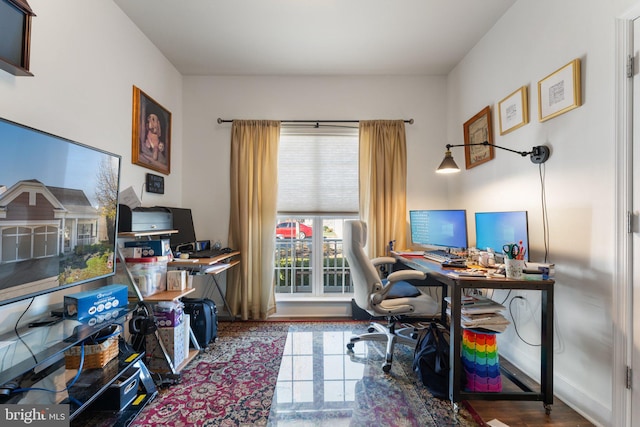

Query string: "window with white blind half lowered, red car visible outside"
[275, 128, 359, 296]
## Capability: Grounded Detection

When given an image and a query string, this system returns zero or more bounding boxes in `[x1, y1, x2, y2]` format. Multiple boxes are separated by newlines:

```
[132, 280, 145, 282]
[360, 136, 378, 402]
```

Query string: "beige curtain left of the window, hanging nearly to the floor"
[226, 120, 280, 320]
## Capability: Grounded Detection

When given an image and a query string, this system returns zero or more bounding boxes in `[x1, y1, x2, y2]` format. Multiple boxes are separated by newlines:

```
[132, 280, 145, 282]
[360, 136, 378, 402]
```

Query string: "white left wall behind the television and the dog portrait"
[0, 0, 182, 330]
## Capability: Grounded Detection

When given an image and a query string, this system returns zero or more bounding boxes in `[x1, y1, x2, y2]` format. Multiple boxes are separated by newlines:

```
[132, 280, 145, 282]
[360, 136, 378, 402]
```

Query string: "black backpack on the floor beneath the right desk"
[413, 322, 449, 399]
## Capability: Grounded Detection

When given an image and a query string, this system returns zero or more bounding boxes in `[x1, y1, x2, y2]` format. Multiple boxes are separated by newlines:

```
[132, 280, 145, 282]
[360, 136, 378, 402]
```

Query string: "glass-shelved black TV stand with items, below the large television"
[0, 306, 157, 425]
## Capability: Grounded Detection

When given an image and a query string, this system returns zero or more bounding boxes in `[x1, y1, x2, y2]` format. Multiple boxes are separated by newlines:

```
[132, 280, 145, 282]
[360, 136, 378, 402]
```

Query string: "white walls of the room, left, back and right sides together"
[0, 0, 633, 425]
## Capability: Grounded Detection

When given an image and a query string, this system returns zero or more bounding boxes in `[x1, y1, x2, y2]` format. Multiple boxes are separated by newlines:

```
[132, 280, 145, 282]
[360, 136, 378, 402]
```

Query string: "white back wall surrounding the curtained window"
[182, 77, 446, 244]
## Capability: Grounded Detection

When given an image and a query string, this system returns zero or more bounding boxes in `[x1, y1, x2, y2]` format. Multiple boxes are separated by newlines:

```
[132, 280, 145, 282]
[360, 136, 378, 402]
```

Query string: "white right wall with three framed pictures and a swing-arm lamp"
[447, 0, 632, 425]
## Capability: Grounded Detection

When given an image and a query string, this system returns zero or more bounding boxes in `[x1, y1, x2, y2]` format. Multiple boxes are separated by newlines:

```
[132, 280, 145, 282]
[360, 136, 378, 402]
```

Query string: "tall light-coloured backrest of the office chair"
[343, 220, 383, 311]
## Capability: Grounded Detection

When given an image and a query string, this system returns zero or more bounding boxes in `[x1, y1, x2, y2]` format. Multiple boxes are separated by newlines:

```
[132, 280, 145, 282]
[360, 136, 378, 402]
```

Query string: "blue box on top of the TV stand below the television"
[64, 285, 129, 320]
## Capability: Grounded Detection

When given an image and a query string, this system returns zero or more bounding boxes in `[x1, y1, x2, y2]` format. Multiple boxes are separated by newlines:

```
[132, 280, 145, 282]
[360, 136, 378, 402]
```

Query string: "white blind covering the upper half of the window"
[278, 128, 358, 214]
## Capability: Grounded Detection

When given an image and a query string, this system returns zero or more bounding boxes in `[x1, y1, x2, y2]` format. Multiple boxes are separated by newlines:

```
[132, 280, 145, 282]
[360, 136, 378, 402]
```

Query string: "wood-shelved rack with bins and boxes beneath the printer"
[118, 230, 201, 375]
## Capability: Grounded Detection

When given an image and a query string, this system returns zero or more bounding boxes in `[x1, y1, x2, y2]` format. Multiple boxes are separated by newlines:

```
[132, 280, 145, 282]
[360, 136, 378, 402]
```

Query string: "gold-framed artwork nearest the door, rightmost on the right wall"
[538, 59, 581, 122]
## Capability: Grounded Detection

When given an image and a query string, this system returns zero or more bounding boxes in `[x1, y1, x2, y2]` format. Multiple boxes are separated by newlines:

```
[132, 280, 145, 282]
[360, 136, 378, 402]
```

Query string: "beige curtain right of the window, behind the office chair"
[359, 120, 407, 257]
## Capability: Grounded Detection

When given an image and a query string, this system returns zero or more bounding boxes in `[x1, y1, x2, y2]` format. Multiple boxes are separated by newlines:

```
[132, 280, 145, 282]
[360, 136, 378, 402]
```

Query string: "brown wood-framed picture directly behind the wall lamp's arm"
[464, 106, 494, 169]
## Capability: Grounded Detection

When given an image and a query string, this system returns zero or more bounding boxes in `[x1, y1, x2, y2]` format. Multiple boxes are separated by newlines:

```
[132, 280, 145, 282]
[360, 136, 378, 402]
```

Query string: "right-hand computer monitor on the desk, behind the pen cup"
[475, 211, 529, 261]
